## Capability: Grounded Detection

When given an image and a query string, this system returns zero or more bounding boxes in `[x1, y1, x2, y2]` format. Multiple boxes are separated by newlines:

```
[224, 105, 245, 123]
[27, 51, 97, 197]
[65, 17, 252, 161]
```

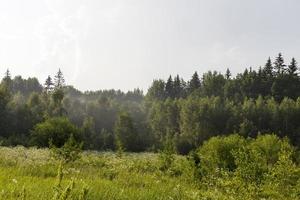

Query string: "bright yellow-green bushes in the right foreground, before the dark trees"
[190, 135, 300, 199]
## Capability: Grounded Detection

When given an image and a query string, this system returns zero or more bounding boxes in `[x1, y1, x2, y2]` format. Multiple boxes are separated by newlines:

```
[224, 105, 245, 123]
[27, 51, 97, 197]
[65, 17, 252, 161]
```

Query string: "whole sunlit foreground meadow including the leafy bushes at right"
[0, 135, 300, 200]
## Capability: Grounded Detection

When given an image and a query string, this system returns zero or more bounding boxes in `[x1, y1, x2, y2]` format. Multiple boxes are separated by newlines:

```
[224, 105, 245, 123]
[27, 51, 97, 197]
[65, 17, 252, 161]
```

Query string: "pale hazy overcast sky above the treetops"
[0, 0, 300, 91]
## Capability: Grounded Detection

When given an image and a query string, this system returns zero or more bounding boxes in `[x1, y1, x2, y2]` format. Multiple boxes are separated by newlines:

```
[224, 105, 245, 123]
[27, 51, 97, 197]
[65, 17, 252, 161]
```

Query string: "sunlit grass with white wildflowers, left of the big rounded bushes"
[0, 147, 198, 200]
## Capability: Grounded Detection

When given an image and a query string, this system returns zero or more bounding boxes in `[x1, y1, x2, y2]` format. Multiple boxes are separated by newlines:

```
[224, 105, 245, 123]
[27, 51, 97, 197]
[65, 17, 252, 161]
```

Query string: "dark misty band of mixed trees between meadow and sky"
[0, 54, 300, 154]
